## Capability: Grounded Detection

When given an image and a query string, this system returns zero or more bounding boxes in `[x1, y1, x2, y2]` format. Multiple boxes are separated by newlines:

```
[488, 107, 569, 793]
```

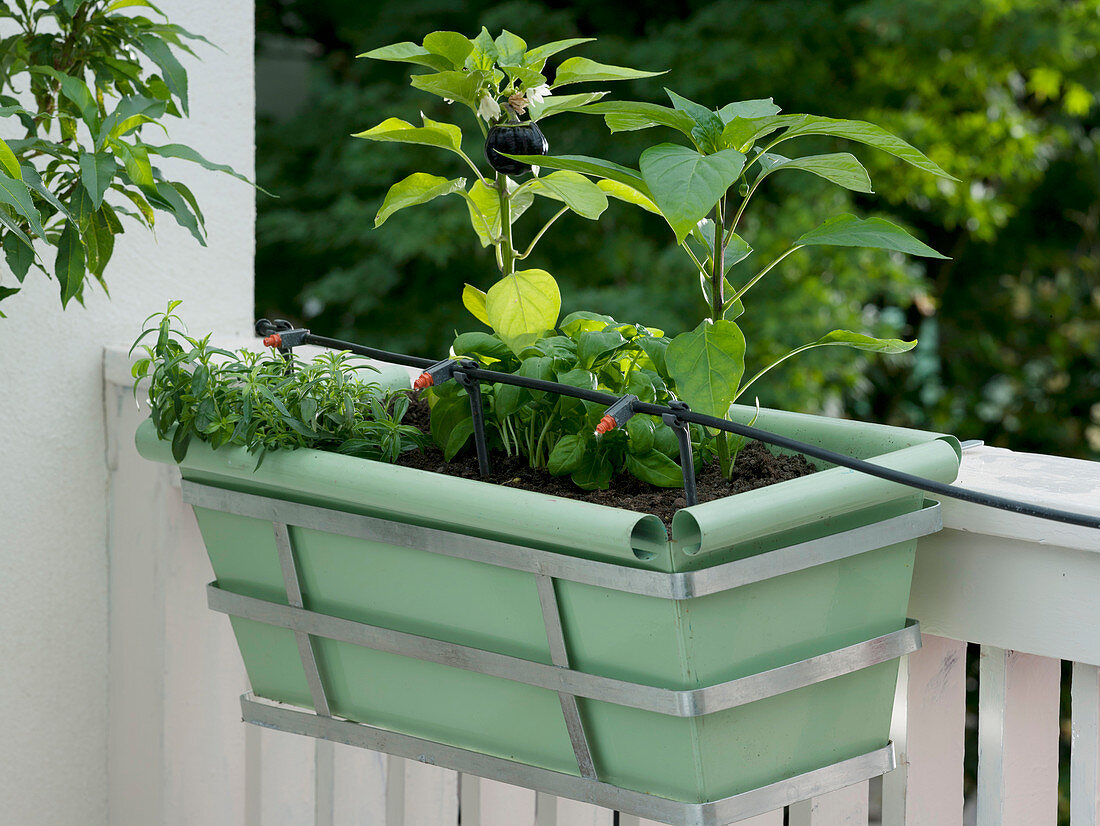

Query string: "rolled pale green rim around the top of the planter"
[135, 406, 960, 570]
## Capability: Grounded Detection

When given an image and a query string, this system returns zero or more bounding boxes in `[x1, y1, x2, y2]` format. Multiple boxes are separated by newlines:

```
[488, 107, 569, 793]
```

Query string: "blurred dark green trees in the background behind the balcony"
[256, 0, 1100, 458]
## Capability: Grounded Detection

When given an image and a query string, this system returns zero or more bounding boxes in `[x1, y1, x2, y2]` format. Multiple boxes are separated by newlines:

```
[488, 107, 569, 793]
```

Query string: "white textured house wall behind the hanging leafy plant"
[0, 0, 255, 826]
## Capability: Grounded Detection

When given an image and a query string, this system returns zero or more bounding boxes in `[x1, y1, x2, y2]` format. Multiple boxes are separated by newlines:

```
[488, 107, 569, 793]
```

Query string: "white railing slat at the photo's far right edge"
[1069, 662, 1100, 826]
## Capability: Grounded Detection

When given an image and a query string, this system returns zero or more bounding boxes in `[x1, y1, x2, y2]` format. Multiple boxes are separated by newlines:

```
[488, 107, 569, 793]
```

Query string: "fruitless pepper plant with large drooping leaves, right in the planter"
[512, 90, 956, 477]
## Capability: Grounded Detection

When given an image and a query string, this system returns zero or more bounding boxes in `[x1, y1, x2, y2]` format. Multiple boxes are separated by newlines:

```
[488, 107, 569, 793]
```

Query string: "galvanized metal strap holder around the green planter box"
[183, 481, 942, 826]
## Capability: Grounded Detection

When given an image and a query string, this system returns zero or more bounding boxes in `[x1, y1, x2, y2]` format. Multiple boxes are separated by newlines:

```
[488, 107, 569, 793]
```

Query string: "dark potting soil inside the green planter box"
[398, 398, 816, 526]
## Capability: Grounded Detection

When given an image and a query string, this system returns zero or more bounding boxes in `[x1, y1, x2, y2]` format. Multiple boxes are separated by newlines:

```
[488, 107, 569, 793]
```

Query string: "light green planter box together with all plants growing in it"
[135, 31, 959, 817]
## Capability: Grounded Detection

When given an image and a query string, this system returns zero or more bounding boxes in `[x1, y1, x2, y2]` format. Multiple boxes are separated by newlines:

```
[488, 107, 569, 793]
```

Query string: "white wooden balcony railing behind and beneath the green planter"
[105, 352, 1100, 826]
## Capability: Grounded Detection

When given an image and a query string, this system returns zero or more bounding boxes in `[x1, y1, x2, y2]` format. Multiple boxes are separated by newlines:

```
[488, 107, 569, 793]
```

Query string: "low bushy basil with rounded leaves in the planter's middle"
[429, 311, 713, 489]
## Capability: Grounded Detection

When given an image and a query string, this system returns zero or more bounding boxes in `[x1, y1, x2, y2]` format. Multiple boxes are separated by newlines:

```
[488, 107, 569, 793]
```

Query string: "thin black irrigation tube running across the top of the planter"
[256, 322, 1100, 529]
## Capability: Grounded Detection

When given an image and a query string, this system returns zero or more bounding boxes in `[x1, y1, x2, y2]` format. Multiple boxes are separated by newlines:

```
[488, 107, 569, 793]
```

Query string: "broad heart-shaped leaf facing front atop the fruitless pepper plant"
[640, 143, 745, 243]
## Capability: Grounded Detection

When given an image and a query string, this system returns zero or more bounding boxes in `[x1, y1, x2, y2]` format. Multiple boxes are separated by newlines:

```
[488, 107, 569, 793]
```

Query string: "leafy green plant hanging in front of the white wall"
[0, 0, 255, 318]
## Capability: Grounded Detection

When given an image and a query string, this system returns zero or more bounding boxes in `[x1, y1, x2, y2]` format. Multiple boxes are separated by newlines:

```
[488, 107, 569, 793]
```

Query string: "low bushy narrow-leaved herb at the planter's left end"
[130, 301, 425, 466]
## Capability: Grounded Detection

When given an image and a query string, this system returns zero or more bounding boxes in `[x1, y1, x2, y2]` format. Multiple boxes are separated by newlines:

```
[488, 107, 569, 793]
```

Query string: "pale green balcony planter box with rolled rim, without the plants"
[138, 407, 960, 823]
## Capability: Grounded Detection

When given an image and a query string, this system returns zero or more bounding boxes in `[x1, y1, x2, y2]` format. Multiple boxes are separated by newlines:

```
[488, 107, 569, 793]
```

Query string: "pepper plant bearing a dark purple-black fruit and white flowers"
[355, 29, 661, 353]
